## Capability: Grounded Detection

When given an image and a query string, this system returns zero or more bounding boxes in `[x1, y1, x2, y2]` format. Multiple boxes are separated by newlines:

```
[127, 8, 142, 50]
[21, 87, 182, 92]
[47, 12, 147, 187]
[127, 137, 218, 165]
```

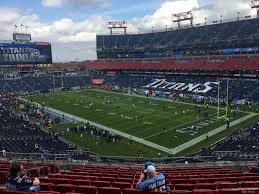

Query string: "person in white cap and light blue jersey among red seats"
[137, 165, 170, 192]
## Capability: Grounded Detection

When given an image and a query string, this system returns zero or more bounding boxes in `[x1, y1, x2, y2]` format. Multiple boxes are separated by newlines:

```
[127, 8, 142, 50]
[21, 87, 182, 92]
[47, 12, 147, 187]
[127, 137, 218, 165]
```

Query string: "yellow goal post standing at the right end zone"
[217, 79, 229, 120]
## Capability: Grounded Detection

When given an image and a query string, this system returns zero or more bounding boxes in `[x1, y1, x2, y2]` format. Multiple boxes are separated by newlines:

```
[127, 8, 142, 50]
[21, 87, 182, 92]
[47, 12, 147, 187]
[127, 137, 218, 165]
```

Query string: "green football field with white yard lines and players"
[26, 90, 250, 156]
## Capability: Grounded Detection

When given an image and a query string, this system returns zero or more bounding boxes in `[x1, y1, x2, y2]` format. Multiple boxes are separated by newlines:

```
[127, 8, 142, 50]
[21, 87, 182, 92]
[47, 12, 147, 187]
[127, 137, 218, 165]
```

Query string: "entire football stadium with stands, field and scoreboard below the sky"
[0, 0, 259, 194]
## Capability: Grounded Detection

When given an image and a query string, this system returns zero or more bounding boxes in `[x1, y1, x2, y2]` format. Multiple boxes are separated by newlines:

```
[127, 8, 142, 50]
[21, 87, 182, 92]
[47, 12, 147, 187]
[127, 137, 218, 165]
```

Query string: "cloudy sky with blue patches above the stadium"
[0, 0, 256, 61]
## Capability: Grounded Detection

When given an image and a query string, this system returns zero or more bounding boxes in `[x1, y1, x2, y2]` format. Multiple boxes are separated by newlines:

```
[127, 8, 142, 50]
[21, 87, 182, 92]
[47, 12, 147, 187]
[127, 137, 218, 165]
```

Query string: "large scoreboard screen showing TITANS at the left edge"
[0, 42, 52, 65]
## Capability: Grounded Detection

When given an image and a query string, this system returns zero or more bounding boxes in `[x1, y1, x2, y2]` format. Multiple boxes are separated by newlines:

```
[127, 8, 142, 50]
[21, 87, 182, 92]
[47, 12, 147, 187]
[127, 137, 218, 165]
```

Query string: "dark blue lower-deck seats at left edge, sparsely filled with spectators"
[0, 98, 76, 154]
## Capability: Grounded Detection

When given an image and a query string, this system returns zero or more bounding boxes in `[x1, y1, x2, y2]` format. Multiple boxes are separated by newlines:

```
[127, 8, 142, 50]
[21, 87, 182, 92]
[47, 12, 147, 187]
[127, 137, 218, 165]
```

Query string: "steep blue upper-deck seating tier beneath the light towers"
[97, 18, 259, 59]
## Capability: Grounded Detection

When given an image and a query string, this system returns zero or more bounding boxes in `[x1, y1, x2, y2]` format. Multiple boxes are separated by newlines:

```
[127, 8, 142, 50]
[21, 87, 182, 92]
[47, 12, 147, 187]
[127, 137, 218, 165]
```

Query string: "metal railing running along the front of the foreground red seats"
[0, 151, 256, 169]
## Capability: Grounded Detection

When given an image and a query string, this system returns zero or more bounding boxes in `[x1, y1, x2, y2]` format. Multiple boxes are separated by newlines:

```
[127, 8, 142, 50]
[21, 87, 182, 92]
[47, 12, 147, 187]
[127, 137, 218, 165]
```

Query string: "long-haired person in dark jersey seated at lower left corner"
[6, 162, 40, 193]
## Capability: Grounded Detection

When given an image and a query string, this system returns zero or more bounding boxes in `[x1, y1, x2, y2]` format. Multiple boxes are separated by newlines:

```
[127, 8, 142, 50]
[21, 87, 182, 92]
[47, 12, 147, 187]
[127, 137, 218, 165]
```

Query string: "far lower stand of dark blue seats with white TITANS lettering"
[105, 74, 259, 102]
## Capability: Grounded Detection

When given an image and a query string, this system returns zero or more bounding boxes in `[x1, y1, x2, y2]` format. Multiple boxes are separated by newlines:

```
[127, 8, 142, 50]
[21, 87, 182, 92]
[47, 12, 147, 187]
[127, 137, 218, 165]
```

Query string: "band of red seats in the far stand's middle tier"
[86, 56, 259, 73]
